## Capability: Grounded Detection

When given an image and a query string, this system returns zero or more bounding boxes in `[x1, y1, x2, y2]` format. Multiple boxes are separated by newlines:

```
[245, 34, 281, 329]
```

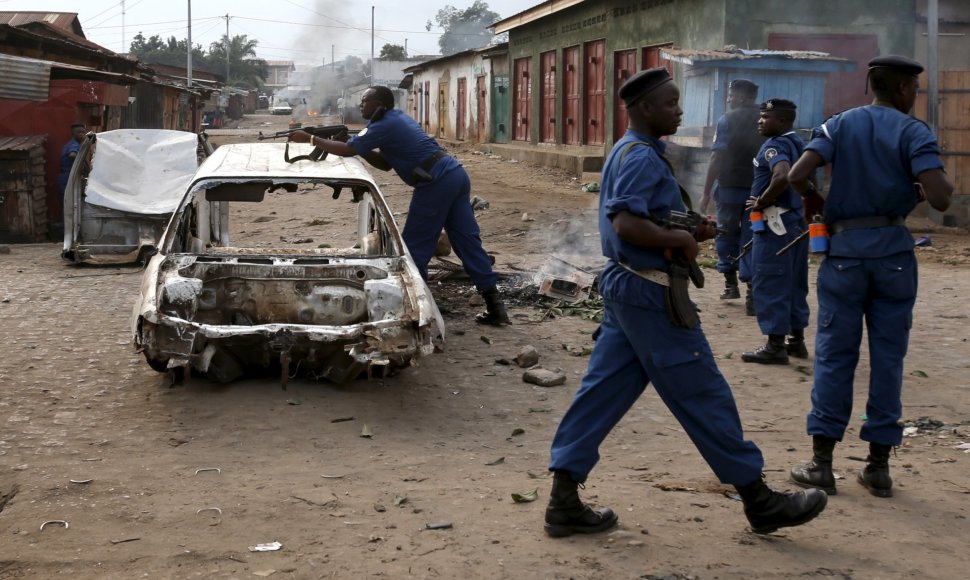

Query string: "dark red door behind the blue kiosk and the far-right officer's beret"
[768, 33, 879, 117]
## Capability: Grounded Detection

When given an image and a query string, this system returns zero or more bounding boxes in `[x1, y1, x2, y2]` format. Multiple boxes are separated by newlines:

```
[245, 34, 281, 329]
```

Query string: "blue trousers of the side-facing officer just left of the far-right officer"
[751, 211, 809, 335]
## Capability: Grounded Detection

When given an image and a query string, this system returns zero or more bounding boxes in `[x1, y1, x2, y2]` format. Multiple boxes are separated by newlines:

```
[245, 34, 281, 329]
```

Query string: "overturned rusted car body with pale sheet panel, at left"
[61, 129, 212, 264]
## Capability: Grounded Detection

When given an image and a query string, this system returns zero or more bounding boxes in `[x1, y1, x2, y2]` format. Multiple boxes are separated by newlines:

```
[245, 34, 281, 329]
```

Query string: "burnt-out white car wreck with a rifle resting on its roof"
[132, 143, 444, 384]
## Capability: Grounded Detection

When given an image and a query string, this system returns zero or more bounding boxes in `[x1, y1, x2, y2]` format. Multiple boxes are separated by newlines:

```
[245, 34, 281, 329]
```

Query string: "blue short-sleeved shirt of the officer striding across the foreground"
[599, 129, 686, 270]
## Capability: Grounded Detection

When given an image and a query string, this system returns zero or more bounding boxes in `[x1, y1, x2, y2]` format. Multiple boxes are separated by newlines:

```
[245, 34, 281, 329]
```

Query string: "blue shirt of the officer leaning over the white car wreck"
[347, 109, 460, 186]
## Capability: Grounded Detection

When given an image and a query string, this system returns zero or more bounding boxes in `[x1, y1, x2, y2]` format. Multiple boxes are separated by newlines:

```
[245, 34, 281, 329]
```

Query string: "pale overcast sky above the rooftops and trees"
[0, 0, 528, 64]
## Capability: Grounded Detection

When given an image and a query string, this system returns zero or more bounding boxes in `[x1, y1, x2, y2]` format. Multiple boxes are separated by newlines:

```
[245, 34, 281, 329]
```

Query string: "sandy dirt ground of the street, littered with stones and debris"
[0, 115, 970, 579]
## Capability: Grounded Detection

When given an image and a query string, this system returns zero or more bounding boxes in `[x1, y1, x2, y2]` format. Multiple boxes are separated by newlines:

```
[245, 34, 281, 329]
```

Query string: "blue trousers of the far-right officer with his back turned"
[808, 251, 917, 445]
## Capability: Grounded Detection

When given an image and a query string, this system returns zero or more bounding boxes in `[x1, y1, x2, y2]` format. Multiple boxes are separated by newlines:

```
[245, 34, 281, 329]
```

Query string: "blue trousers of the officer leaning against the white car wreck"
[401, 167, 498, 292]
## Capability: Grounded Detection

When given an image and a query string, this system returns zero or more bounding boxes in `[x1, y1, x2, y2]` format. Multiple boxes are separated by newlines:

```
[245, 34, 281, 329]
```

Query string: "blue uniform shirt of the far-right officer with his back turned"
[805, 105, 943, 258]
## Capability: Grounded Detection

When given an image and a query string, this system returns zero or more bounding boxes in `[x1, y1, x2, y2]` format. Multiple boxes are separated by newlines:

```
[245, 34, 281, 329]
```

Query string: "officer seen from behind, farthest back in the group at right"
[698, 79, 765, 316]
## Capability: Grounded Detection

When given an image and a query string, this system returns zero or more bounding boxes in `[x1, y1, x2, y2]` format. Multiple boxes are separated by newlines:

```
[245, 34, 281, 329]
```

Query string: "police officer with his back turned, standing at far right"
[788, 56, 953, 497]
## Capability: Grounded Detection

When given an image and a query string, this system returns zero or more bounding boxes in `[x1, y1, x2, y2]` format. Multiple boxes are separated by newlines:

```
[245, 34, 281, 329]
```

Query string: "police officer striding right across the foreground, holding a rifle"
[545, 68, 826, 537]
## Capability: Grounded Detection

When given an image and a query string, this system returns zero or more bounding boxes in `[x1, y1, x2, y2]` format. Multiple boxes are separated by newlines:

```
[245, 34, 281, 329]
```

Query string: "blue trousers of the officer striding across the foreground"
[549, 265, 764, 485]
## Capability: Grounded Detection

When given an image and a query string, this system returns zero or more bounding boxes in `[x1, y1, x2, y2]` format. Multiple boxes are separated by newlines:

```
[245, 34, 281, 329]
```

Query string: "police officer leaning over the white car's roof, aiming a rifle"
[290, 86, 509, 326]
